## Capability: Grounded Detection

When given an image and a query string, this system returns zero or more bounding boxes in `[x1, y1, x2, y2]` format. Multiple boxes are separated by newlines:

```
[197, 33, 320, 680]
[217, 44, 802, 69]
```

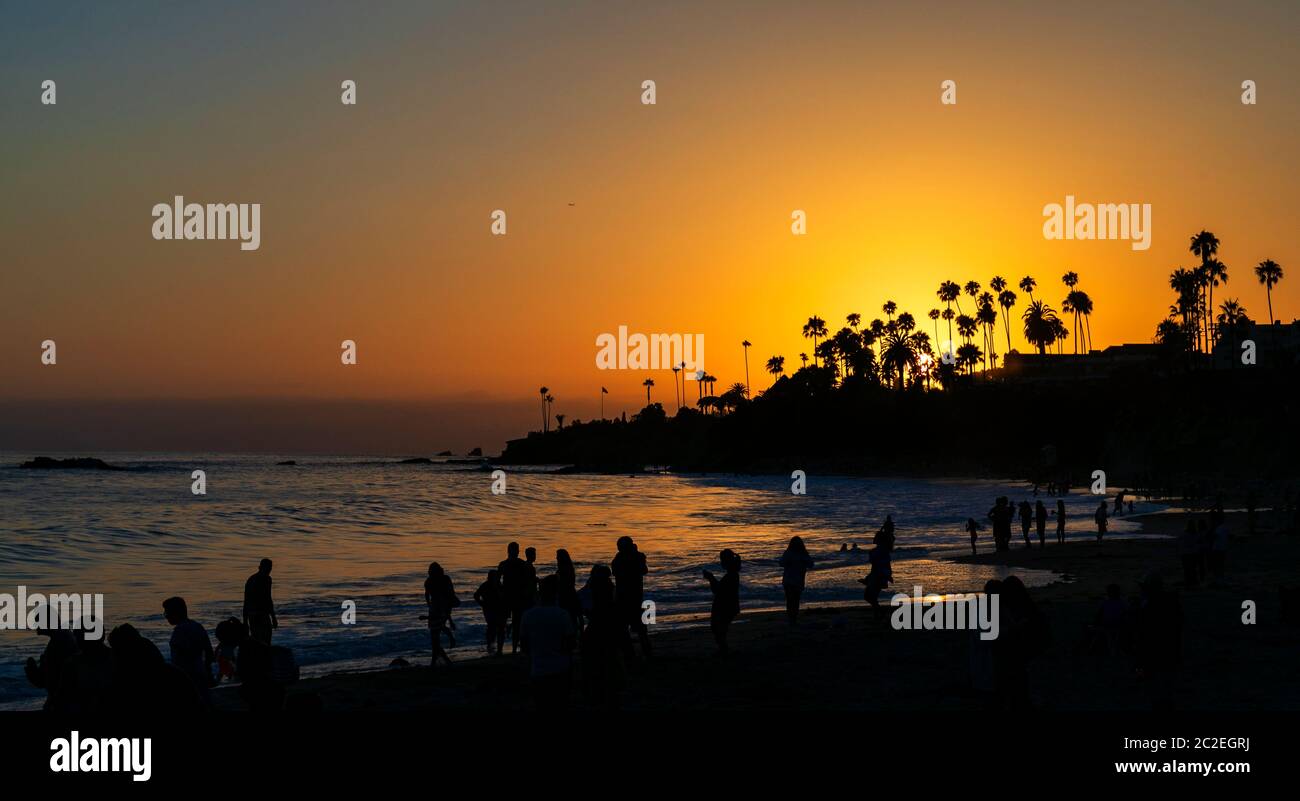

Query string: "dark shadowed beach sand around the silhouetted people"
[215, 512, 1300, 711]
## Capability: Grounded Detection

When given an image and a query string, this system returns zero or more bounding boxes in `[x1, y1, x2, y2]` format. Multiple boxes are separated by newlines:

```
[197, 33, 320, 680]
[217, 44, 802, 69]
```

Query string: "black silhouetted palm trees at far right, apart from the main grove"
[1156, 230, 1282, 352]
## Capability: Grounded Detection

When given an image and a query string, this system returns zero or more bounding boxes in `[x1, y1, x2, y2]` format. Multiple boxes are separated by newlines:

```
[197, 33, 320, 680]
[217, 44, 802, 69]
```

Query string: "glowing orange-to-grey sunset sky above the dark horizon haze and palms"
[0, 1, 1300, 447]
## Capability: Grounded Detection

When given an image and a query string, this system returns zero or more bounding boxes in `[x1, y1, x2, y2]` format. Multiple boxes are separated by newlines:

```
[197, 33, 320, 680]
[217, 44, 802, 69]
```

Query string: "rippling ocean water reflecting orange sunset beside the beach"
[0, 454, 1157, 706]
